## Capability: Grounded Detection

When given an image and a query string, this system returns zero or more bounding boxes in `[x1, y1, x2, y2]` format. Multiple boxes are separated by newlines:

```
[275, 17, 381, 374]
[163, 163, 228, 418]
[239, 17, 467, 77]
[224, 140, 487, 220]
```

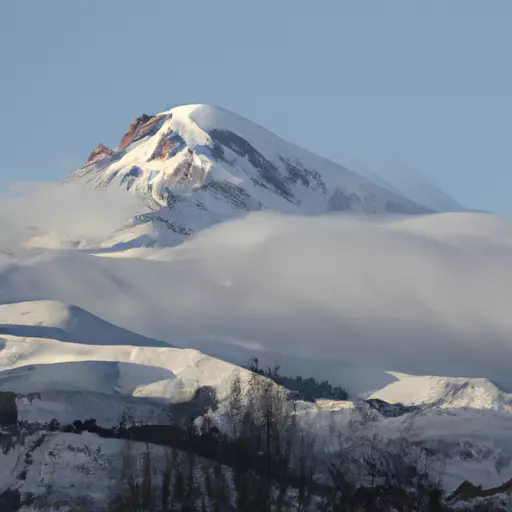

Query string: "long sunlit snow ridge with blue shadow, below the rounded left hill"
[0, 336, 246, 401]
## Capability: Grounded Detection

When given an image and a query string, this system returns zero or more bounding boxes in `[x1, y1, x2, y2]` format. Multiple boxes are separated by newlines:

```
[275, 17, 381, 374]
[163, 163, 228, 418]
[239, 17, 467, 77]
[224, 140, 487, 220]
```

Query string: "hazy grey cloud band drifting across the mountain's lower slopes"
[0, 184, 512, 387]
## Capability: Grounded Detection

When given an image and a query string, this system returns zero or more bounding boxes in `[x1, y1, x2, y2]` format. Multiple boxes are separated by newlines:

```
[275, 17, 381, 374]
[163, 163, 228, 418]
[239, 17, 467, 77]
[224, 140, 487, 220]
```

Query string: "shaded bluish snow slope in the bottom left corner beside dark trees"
[0, 432, 176, 512]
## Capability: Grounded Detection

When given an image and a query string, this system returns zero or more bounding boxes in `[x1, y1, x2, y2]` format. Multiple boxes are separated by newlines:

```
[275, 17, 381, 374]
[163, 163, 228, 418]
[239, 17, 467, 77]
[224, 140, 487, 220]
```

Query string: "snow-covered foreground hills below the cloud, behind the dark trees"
[0, 301, 512, 510]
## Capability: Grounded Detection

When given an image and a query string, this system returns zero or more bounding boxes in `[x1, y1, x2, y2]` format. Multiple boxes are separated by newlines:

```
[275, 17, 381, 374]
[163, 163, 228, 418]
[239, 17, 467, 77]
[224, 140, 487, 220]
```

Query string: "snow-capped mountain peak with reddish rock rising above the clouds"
[67, 105, 432, 246]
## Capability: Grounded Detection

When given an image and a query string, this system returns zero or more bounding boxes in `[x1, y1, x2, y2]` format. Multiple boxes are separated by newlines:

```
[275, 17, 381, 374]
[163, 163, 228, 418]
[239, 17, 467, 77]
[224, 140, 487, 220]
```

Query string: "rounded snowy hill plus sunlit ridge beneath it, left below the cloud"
[0, 301, 250, 398]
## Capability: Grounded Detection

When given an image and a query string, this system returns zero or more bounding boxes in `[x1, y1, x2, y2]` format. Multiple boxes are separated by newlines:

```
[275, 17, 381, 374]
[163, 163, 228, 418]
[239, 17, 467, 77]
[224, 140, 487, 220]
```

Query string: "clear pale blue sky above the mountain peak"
[0, 0, 512, 213]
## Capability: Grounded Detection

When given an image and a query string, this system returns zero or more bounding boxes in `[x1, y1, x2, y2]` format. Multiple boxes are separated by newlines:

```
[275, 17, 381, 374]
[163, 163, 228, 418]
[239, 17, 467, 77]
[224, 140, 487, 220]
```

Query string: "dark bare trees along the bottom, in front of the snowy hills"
[109, 366, 449, 512]
